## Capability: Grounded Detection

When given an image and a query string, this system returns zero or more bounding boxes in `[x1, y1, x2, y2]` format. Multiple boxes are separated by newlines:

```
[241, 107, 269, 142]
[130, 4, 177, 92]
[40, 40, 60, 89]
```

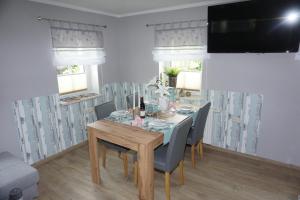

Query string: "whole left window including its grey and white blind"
[49, 20, 106, 96]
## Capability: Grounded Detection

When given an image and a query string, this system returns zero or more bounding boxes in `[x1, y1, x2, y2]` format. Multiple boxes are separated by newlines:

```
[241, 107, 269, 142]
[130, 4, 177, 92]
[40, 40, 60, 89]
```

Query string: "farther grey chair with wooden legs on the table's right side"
[187, 102, 211, 168]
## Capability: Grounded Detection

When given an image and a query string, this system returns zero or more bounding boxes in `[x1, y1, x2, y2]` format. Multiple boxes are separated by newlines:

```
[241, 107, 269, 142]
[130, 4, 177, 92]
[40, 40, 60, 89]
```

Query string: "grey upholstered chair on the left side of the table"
[95, 101, 129, 177]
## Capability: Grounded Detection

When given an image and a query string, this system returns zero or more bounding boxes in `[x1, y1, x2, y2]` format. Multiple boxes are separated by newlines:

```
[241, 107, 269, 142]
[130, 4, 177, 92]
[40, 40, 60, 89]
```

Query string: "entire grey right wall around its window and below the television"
[119, 7, 300, 165]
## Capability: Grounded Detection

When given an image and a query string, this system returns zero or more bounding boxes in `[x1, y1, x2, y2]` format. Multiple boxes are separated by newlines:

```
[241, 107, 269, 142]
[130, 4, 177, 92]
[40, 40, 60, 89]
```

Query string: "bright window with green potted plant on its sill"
[159, 60, 203, 90]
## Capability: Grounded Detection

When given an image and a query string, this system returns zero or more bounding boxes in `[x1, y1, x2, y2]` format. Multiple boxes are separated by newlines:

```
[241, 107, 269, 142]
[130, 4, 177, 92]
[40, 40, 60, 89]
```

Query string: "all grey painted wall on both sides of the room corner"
[0, 0, 300, 165]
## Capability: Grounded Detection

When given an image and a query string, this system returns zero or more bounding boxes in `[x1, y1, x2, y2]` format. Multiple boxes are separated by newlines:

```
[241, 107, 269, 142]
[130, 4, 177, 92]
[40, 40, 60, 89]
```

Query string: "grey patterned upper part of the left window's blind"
[50, 20, 104, 48]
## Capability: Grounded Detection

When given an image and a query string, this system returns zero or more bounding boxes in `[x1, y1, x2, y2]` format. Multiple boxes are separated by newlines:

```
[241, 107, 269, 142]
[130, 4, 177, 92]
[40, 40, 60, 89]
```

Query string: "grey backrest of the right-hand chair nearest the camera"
[166, 117, 193, 171]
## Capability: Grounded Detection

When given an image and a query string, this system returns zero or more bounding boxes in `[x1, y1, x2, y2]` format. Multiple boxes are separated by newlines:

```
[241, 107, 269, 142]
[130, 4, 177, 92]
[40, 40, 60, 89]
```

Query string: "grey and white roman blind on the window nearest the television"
[153, 20, 207, 62]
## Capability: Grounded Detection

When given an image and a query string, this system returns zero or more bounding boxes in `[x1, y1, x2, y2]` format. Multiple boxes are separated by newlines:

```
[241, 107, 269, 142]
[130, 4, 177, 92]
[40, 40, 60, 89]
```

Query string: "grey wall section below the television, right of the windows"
[207, 54, 300, 166]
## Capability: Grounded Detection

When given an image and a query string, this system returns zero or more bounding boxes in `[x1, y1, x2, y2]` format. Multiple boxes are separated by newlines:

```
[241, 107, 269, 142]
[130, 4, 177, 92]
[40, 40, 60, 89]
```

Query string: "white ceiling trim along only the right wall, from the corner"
[118, 0, 241, 18]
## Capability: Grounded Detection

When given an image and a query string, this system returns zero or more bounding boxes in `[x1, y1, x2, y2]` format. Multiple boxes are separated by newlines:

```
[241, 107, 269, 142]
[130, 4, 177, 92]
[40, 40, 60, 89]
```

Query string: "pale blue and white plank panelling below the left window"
[13, 94, 108, 164]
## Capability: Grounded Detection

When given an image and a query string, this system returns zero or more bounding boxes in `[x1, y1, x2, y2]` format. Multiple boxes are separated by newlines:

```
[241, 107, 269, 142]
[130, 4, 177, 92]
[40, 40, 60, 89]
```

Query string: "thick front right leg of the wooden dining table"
[138, 145, 154, 200]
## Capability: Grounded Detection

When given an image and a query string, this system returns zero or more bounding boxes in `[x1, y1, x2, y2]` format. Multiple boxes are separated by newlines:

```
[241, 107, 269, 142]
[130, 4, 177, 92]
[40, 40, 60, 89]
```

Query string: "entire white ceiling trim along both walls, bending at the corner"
[28, 0, 247, 18]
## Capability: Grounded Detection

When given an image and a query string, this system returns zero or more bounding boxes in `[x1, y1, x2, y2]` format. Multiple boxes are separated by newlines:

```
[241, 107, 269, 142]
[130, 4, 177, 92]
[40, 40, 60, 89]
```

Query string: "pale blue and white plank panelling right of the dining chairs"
[202, 90, 263, 155]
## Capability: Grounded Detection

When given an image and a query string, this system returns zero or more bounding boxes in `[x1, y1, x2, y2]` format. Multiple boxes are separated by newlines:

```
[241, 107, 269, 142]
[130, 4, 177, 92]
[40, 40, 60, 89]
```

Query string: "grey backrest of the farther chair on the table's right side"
[192, 102, 211, 142]
